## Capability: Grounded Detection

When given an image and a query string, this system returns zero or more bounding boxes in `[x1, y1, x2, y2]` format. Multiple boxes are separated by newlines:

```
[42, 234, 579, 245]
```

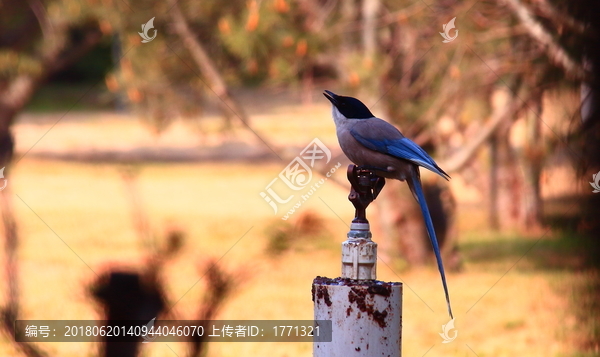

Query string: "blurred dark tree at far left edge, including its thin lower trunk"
[0, 0, 108, 350]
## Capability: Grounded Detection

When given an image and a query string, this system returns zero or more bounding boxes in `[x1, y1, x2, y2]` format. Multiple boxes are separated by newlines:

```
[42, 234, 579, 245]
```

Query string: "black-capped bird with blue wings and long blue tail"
[323, 90, 454, 319]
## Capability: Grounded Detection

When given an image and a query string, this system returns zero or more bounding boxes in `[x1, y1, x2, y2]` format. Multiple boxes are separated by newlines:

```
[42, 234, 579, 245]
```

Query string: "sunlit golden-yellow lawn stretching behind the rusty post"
[0, 102, 589, 357]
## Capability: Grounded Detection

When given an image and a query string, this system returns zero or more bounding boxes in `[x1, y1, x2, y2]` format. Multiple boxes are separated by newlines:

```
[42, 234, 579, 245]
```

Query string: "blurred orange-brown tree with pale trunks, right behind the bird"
[338, 0, 590, 264]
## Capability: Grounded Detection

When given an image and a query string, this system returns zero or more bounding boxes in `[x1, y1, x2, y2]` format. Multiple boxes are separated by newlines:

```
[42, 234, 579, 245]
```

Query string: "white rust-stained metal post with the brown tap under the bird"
[312, 165, 402, 357]
